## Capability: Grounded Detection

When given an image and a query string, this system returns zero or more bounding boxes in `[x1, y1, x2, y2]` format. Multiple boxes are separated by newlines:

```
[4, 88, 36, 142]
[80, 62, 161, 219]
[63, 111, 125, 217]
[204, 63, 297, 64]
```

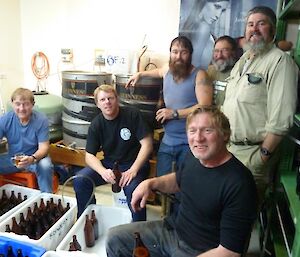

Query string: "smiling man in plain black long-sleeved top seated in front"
[106, 107, 257, 257]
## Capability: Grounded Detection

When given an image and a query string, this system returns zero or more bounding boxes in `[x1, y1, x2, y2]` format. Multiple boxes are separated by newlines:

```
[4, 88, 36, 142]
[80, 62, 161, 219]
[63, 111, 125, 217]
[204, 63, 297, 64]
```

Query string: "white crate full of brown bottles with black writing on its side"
[0, 193, 77, 250]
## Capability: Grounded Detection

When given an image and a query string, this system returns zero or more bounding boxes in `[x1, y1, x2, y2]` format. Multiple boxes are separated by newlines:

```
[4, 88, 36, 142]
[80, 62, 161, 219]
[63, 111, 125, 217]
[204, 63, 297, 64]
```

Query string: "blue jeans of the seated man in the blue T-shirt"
[0, 153, 53, 193]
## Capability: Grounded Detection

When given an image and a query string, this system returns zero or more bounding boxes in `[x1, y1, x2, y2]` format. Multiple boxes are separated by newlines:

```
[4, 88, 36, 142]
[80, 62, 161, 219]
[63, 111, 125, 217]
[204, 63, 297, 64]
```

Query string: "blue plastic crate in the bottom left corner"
[0, 236, 46, 257]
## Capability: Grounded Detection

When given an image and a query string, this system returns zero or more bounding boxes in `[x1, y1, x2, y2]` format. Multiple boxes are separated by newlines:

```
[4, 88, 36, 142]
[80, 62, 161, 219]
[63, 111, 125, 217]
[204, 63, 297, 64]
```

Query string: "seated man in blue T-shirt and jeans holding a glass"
[0, 88, 53, 193]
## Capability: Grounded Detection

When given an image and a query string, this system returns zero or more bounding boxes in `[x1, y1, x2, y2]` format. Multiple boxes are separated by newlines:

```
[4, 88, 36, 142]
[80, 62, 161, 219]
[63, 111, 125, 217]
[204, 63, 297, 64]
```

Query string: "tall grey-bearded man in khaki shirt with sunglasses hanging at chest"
[223, 6, 298, 200]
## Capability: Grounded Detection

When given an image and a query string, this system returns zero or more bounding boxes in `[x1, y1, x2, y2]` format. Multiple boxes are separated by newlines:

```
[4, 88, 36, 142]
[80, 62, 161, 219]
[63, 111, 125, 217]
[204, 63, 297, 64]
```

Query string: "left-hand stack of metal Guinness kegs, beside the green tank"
[62, 70, 112, 148]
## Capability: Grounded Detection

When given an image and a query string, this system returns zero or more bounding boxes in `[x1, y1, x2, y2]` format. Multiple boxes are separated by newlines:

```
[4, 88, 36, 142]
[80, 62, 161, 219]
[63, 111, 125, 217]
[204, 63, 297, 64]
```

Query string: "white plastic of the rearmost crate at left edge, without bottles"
[0, 184, 41, 223]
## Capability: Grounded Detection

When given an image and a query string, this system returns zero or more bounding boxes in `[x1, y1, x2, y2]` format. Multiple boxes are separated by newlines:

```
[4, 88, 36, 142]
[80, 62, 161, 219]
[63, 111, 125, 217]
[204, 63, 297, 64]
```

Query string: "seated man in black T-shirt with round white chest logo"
[74, 85, 152, 221]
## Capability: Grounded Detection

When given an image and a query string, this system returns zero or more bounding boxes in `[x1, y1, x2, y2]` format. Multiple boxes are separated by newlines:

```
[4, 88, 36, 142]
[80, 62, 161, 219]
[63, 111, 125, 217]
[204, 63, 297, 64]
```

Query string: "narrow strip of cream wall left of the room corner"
[0, 0, 23, 113]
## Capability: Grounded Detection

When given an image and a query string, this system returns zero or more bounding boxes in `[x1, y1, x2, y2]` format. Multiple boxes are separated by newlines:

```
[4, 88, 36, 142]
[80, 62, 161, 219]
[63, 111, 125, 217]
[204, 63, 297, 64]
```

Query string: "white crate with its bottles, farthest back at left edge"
[0, 184, 41, 222]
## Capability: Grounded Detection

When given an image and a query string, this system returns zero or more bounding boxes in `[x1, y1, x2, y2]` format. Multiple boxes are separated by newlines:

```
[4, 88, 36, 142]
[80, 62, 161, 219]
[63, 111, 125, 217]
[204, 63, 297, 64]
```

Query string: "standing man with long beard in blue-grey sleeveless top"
[126, 36, 213, 214]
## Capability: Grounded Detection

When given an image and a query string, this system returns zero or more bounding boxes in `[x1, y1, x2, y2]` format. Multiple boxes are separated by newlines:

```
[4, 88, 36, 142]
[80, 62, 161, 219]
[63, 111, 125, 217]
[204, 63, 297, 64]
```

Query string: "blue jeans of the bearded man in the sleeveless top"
[156, 142, 189, 215]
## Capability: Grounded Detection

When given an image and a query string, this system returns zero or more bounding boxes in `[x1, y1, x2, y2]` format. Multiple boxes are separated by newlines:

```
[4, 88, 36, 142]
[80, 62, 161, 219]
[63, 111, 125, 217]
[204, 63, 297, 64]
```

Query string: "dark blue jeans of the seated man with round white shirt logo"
[73, 160, 150, 221]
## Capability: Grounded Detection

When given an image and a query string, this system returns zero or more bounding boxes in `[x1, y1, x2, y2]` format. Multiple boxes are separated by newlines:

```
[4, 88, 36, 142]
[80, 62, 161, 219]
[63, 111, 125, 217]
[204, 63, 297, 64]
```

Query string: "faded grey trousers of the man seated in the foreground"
[106, 217, 201, 257]
